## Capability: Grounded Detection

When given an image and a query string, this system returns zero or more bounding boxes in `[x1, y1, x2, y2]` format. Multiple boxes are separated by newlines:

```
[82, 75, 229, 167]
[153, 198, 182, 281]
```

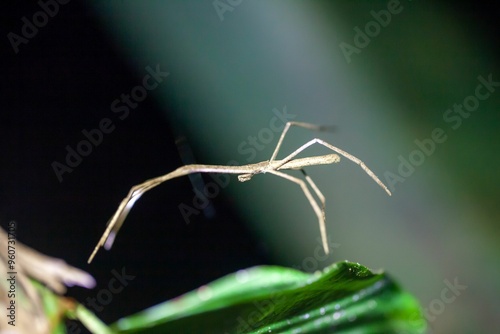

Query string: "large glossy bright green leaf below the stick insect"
[110, 262, 426, 334]
